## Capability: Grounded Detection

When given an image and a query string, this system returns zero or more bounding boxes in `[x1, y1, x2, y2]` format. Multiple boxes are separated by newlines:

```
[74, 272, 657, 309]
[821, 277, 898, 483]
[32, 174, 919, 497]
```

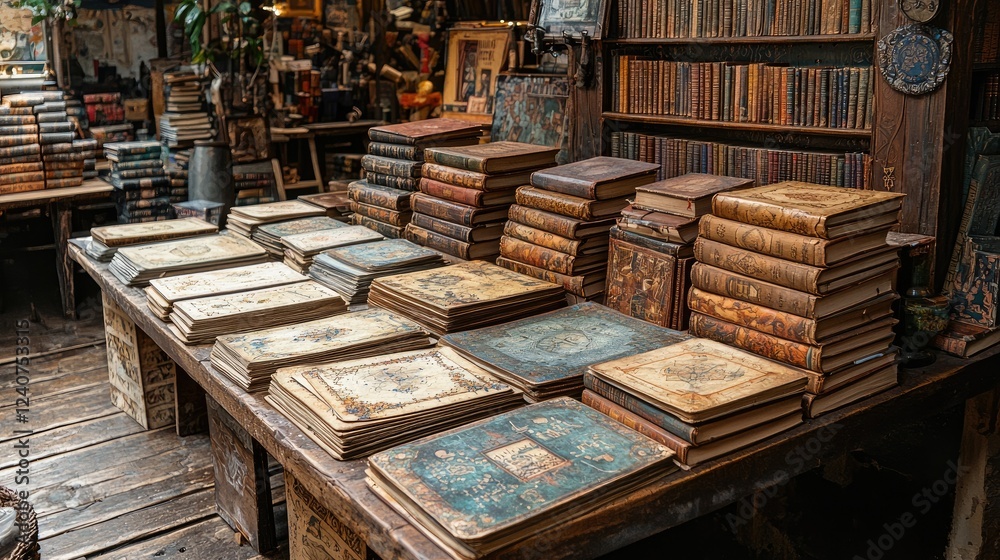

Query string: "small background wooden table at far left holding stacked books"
[0, 179, 114, 319]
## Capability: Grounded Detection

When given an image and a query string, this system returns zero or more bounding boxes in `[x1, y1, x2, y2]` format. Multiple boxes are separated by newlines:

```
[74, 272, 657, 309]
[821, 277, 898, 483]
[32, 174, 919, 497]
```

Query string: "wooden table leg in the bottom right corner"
[945, 388, 1000, 560]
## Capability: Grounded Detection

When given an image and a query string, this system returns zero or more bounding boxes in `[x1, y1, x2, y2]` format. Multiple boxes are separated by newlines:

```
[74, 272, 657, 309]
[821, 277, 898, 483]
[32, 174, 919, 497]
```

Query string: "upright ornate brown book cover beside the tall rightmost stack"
[604, 235, 677, 327]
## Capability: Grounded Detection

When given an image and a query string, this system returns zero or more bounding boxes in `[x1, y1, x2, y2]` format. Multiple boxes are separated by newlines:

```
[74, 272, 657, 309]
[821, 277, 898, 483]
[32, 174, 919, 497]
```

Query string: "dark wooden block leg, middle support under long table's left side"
[205, 395, 278, 554]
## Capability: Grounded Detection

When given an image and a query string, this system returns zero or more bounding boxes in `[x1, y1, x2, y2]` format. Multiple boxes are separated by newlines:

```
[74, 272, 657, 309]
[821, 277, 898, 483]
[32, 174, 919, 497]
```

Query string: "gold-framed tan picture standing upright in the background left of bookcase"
[442, 27, 510, 114]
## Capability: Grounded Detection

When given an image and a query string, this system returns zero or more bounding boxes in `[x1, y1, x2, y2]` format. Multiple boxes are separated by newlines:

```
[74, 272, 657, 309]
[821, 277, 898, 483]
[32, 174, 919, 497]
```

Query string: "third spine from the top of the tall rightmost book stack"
[694, 238, 823, 295]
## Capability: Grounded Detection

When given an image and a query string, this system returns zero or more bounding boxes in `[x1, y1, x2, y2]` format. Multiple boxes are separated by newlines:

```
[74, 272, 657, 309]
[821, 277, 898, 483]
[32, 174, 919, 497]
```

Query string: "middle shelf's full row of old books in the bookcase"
[612, 56, 874, 129]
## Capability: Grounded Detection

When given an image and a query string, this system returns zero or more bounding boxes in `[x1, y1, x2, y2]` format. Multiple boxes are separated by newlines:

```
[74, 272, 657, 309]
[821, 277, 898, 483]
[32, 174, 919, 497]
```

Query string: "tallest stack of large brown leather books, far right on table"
[688, 182, 903, 417]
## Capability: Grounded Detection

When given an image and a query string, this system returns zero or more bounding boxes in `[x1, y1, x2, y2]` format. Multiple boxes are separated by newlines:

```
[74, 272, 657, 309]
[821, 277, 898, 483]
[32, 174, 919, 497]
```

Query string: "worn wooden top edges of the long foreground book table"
[70, 242, 1000, 560]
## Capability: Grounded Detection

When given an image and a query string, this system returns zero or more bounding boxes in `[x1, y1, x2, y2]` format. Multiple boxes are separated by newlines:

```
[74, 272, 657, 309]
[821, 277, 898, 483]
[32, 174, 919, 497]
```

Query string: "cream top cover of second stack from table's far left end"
[117, 235, 267, 270]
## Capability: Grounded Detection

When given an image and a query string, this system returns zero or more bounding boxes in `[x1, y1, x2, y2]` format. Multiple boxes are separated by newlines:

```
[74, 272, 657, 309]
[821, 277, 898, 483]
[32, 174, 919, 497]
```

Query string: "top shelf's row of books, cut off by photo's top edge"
[617, 0, 872, 39]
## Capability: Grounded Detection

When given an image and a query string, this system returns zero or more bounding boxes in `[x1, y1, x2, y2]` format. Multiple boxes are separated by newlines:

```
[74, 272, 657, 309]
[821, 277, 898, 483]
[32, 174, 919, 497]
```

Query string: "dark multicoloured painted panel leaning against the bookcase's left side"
[490, 74, 570, 164]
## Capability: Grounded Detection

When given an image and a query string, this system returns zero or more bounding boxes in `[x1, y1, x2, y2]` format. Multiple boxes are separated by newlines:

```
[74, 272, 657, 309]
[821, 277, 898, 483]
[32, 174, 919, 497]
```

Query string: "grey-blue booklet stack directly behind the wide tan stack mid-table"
[309, 238, 444, 305]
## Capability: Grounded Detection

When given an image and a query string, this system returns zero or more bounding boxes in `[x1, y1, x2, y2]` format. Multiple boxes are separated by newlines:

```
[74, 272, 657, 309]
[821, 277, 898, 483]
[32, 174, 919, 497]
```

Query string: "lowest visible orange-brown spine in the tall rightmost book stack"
[689, 312, 823, 372]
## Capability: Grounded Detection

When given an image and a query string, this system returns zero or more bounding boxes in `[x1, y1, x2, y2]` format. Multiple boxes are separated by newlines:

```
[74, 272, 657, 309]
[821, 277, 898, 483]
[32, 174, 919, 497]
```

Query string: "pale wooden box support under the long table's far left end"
[103, 295, 177, 430]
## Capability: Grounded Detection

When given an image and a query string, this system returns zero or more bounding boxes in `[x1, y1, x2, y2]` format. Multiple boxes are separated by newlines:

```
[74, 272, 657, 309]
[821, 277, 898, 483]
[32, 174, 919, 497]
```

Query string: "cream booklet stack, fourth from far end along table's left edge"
[170, 281, 347, 344]
